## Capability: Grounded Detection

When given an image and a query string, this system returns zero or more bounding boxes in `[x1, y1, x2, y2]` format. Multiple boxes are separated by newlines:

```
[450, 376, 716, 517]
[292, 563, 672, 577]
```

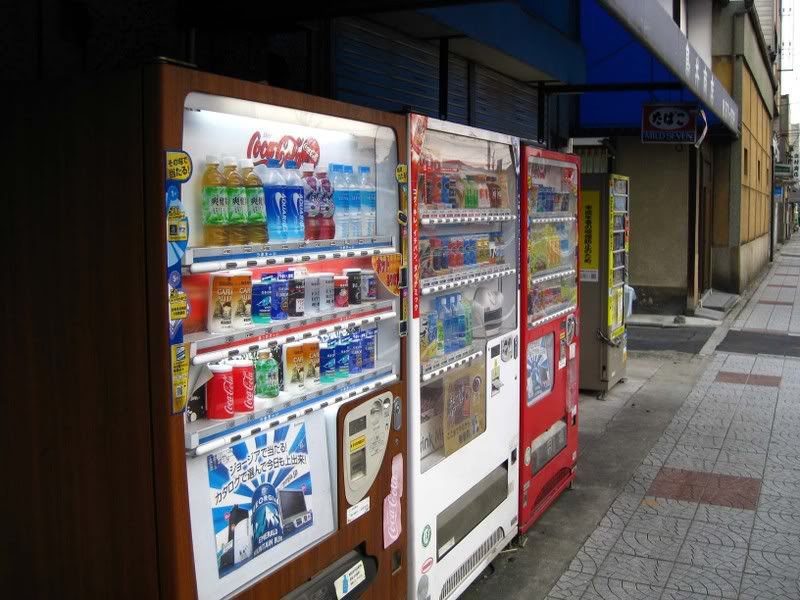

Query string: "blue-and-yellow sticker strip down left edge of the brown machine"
[164, 150, 192, 414]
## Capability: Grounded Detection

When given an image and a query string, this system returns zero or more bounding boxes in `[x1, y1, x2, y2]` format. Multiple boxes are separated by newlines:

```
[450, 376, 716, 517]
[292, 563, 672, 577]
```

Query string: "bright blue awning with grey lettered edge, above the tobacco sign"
[578, 0, 739, 136]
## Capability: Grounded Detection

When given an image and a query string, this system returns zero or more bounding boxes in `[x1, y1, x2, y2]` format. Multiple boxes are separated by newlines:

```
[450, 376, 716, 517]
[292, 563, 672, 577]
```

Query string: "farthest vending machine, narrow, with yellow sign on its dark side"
[579, 173, 630, 395]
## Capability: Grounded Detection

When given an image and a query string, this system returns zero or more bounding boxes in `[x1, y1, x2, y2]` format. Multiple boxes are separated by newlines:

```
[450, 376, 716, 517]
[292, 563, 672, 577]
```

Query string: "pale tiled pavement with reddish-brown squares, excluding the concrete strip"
[547, 244, 800, 600]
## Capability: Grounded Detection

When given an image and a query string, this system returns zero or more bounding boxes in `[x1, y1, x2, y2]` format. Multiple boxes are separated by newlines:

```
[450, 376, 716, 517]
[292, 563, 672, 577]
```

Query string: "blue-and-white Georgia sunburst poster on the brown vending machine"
[207, 423, 314, 578]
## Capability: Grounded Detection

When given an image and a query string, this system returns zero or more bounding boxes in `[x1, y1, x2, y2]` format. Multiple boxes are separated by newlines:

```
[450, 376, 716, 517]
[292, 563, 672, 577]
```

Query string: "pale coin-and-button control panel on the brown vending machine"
[342, 392, 394, 506]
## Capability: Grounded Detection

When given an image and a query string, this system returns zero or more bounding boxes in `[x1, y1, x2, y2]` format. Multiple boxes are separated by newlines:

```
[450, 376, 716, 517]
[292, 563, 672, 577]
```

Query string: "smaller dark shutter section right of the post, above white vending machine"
[474, 65, 538, 139]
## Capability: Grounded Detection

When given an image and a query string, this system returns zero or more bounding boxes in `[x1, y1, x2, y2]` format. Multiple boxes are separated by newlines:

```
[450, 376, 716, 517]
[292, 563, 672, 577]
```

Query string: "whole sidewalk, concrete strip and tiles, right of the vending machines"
[465, 236, 800, 600]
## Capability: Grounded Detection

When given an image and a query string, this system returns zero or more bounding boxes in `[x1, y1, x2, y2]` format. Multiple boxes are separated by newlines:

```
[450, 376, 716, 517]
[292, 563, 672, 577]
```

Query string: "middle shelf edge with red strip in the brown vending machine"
[191, 300, 397, 365]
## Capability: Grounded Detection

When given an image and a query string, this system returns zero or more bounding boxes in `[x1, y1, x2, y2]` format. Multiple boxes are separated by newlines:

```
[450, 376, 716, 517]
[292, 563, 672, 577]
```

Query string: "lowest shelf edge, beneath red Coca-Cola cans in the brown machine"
[185, 363, 397, 456]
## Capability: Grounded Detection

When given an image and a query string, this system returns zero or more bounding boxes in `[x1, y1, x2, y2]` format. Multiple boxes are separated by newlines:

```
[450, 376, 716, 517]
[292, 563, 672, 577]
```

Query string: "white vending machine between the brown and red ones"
[408, 115, 520, 600]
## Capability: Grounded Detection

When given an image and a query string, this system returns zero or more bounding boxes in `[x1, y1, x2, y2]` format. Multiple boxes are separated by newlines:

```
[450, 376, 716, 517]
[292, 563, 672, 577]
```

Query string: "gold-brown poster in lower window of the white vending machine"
[444, 361, 486, 456]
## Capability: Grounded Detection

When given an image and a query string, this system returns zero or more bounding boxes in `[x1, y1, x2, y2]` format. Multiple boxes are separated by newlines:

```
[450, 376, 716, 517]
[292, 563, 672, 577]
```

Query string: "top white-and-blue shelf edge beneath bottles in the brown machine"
[183, 236, 397, 273]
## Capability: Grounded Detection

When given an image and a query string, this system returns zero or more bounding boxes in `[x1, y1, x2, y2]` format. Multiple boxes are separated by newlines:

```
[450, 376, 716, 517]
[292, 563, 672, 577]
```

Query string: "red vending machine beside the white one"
[519, 145, 580, 533]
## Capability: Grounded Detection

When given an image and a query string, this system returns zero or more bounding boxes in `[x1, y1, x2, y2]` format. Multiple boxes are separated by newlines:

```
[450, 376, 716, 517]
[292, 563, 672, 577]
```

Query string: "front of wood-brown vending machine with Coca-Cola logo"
[155, 65, 408, 600]
